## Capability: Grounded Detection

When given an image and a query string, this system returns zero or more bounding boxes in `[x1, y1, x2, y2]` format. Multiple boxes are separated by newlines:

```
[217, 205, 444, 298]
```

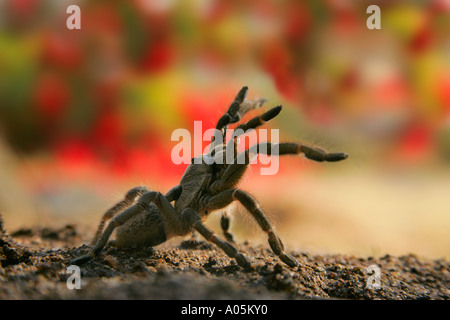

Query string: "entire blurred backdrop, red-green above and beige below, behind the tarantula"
[0, 0, 450, 258]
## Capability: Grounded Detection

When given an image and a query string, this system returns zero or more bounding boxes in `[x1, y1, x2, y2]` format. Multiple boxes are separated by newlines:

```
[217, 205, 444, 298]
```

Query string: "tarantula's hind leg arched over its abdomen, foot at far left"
[70, 191, 189, 265]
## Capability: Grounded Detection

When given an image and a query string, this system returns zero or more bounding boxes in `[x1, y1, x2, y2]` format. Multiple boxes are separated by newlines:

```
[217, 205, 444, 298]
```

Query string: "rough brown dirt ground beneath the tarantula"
[0, 215, 450, 300]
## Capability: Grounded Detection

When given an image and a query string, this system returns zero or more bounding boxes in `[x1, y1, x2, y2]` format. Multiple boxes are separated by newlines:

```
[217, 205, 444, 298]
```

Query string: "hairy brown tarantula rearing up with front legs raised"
[70, 87, 347, 269]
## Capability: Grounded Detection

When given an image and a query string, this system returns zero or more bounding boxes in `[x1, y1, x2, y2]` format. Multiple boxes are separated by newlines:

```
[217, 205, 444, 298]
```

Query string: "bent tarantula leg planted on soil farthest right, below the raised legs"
[205, 189, 298, 267]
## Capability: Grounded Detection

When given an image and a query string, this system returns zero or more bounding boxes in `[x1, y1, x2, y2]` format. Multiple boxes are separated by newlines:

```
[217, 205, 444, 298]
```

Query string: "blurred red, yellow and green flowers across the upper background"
[0, 0, 450, 194]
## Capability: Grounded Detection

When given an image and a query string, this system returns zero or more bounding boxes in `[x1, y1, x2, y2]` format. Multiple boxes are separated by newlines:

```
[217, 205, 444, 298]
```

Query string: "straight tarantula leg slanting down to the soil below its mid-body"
[181, 208, 251, 269]
